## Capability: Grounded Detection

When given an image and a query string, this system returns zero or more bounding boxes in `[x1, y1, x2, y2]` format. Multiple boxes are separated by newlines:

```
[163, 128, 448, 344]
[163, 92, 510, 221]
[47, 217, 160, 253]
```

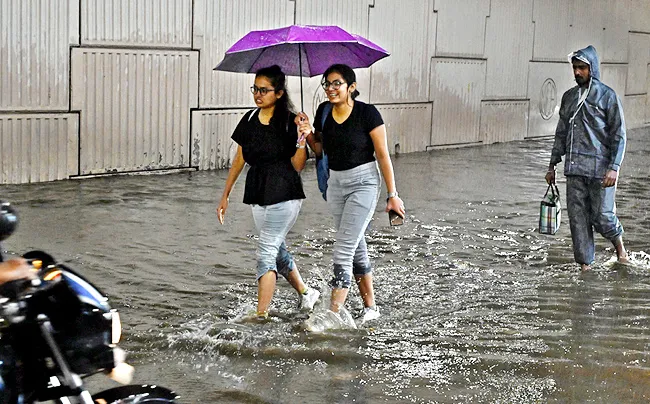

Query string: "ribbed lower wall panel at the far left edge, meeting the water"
[0, 114, 79, 184]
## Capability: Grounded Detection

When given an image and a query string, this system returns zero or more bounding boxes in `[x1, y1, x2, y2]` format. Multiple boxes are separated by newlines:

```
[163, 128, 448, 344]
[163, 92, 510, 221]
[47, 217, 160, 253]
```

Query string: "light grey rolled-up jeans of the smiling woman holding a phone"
[327, 161, 381, 288]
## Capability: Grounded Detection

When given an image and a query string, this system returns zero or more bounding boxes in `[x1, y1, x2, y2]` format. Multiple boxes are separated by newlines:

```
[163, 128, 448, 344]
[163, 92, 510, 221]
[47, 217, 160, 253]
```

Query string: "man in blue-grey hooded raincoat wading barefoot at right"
[546, 45, 628, 271]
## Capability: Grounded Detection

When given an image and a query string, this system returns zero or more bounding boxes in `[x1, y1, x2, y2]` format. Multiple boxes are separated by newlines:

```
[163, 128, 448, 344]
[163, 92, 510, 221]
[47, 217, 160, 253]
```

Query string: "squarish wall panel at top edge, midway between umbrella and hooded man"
[435, 0, 490, 58]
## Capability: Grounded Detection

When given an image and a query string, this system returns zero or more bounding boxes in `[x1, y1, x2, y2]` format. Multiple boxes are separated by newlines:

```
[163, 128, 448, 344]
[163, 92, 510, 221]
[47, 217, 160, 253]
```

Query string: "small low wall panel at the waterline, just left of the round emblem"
[481, 100, 529, 144]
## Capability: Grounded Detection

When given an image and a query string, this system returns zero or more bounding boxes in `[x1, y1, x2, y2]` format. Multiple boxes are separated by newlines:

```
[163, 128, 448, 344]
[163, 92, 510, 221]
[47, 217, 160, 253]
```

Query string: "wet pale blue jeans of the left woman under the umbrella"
[251, 199, 302, 280]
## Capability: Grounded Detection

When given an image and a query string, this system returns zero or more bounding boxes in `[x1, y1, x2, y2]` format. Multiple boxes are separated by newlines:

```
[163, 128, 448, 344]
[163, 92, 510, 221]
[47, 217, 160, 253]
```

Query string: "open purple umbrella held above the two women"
[214, 25, 389, 109]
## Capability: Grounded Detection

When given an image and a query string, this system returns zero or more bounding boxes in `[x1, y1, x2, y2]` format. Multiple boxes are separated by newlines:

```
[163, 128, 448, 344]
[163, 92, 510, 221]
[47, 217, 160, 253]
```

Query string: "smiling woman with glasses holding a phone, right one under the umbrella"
[296, 64, 406, 324]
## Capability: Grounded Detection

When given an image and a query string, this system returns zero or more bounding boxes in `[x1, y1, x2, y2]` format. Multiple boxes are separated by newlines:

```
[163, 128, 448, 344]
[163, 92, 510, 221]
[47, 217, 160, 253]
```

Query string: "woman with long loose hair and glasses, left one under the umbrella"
[217, 66, 320, 318]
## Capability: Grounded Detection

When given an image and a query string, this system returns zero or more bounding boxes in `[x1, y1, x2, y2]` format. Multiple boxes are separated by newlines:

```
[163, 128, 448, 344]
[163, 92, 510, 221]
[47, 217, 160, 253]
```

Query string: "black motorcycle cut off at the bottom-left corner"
[0, 202, 179, 404]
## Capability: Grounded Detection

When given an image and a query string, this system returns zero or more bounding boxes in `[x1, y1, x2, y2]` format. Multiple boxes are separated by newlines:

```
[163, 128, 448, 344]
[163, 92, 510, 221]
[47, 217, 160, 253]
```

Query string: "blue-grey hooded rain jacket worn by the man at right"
[551, 45, 626, 178]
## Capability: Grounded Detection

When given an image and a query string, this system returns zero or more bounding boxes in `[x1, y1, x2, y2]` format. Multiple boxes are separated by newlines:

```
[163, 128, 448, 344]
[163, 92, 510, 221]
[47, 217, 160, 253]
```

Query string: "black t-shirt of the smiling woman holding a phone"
[314, 101, 384, 171]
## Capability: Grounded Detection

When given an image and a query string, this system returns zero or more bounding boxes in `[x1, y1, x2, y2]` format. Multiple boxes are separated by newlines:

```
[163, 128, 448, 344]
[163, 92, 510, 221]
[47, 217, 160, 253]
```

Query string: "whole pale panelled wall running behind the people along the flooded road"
[0, 0, 650, 184]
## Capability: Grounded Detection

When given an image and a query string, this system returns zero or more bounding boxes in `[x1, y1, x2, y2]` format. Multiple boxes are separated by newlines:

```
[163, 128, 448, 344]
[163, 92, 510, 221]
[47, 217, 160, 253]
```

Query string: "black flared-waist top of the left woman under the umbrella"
[232, 109, 305, 206]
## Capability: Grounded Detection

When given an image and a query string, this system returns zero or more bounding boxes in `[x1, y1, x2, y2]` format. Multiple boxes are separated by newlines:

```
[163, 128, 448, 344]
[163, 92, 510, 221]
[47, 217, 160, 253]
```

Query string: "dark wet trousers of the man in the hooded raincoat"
[566, 175, 623, 265]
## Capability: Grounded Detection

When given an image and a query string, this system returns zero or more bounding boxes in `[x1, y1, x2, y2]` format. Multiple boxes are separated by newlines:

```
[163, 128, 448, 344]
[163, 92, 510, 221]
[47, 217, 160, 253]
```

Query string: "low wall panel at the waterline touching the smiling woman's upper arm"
[377, 103, 432, 154]
